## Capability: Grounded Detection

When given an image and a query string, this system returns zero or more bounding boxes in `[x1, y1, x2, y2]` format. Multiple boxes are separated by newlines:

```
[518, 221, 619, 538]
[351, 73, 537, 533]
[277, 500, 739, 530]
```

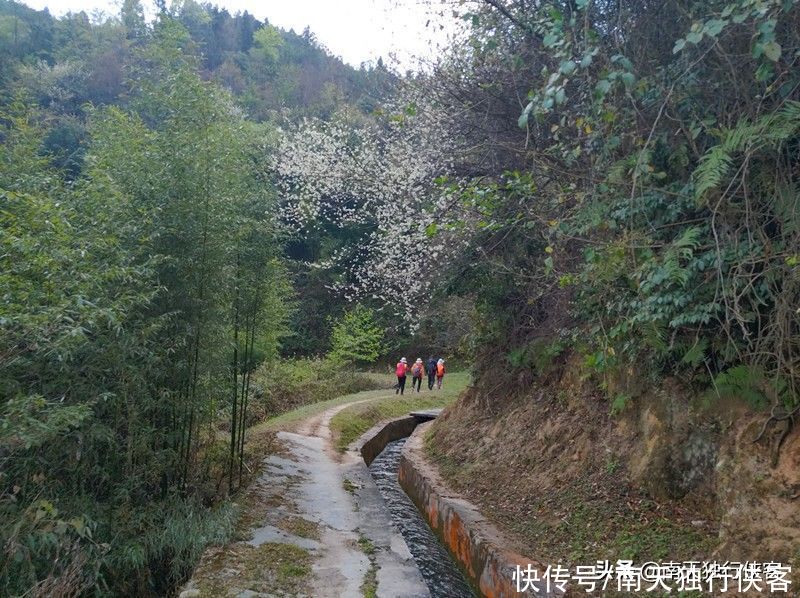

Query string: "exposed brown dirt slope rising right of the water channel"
[426, 356, 800, 571]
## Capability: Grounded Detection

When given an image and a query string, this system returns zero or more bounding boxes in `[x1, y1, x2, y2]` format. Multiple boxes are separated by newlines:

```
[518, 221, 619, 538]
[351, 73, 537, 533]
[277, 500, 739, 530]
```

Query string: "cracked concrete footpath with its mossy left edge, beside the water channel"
[182, 394, 429, 598]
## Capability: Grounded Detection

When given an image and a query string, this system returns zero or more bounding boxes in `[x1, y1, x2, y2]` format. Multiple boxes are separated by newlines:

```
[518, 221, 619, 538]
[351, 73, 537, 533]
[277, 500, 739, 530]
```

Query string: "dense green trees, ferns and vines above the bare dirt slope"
[446, 0, 800, 407]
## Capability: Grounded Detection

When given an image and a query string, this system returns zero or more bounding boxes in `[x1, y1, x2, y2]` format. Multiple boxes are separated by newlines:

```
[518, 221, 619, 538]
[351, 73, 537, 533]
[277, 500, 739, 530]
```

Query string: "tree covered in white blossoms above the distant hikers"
[273, 94, 476, 321]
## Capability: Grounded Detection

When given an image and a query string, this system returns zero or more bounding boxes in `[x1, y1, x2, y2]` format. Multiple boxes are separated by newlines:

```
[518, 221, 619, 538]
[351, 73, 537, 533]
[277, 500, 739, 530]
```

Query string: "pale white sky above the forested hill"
[22, 0, 460, 70]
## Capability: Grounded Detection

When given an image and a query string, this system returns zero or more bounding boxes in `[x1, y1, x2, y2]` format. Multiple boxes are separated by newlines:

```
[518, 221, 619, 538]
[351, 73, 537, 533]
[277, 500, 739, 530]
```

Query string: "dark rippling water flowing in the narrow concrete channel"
[369, 438, 475, 598]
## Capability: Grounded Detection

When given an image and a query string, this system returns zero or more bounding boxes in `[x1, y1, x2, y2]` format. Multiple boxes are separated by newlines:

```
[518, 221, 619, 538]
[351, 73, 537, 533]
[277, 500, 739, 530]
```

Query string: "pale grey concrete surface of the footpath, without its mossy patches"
[184, 403, 429, 598]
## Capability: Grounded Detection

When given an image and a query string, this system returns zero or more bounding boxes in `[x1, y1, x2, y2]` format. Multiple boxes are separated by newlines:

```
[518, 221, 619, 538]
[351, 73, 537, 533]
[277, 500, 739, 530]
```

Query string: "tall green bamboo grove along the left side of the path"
[0, 19, 288, 595]
